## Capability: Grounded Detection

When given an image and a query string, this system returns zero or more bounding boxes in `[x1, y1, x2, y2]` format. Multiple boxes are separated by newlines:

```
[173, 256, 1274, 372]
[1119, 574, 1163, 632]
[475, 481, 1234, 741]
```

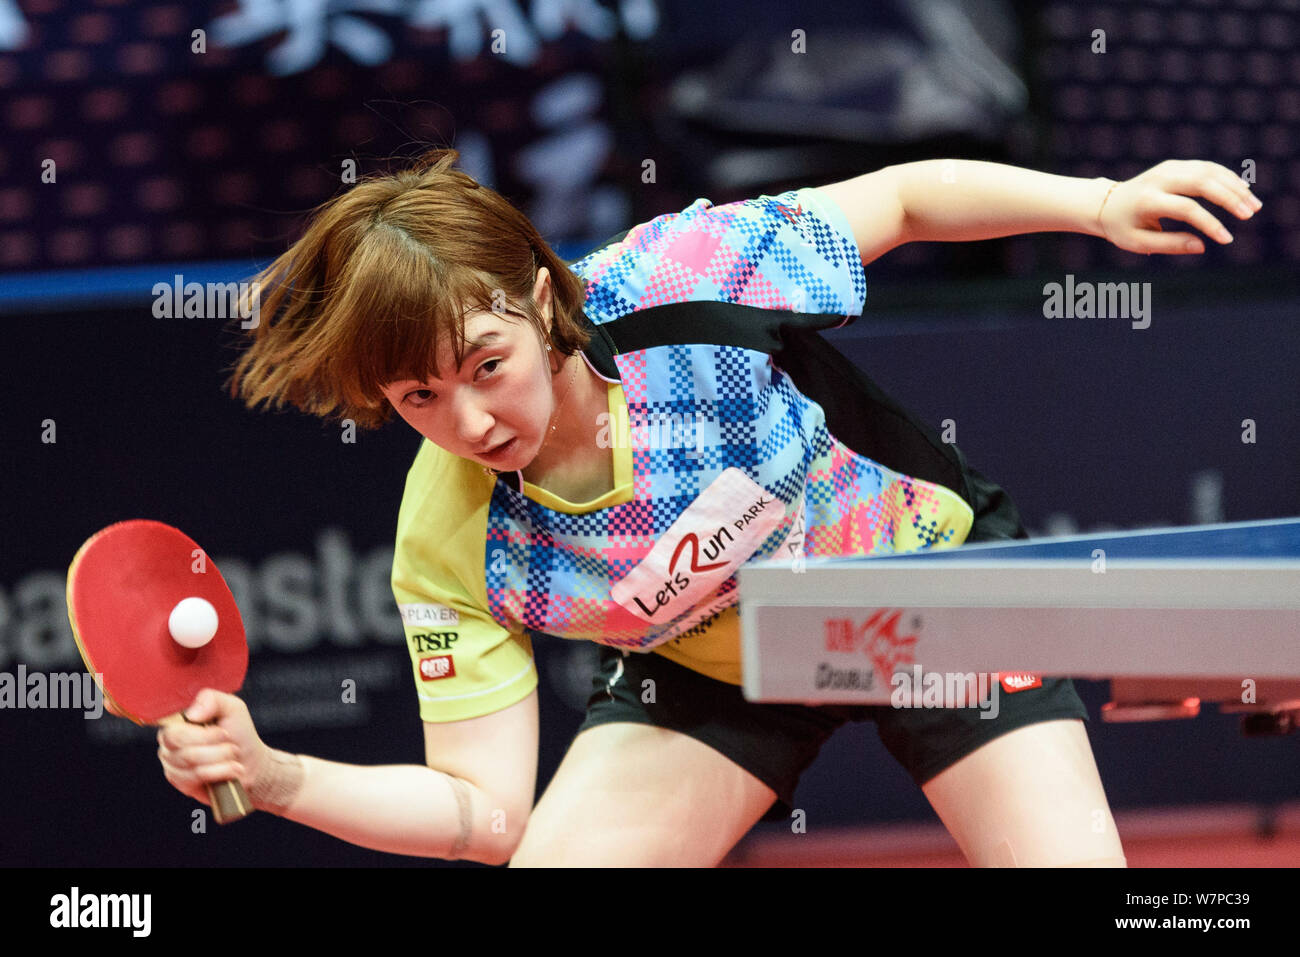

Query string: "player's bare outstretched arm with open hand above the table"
[818, 160, 1262, 263]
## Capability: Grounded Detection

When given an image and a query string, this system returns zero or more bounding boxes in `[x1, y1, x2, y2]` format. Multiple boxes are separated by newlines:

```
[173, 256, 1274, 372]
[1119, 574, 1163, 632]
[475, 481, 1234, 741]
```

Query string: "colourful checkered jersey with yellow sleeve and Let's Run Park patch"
[393, 189, 982, 722]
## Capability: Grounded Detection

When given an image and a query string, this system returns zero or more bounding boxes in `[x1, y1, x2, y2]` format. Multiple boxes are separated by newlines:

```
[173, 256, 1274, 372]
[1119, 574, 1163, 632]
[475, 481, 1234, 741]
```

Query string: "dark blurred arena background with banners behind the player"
[0, 0, 1300, 866]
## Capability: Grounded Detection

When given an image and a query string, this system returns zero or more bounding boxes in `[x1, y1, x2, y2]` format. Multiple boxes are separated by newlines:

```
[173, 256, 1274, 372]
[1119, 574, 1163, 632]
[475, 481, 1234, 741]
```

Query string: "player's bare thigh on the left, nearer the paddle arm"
[511, 722, 776, 867]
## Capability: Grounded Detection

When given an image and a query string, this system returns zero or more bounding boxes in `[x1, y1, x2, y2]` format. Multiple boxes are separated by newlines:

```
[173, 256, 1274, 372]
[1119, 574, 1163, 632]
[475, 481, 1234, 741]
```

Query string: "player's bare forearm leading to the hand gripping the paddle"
[248, 752, 516, 865]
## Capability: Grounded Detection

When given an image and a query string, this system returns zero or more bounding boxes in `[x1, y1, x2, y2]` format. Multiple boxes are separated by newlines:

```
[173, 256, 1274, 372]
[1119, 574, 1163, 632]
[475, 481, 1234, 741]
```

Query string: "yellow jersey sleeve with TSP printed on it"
[393, 441, 537, 722]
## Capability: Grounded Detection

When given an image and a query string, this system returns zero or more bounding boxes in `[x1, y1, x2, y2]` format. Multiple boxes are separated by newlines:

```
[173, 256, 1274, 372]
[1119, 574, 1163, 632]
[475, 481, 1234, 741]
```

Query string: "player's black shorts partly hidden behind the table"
[579, 648, 1088, 820]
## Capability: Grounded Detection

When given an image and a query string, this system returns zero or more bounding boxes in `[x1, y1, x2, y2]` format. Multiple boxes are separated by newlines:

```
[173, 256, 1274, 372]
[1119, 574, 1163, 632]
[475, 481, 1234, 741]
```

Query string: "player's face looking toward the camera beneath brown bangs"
[384, 312, 554, 472]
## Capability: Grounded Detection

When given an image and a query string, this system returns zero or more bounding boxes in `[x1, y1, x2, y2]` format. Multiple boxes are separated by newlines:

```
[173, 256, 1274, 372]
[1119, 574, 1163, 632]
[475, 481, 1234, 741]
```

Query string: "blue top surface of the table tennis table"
[815, 519, 1300, 564]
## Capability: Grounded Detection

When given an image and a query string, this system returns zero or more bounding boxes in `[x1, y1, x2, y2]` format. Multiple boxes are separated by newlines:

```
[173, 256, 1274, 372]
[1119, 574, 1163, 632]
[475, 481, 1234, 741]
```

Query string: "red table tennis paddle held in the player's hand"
[68, 519, 252, 824]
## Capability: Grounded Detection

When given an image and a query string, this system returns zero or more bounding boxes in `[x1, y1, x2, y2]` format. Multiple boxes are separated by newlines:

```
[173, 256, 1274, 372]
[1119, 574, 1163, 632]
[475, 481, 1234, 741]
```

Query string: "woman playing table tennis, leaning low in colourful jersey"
[159, 151, 1260, 866]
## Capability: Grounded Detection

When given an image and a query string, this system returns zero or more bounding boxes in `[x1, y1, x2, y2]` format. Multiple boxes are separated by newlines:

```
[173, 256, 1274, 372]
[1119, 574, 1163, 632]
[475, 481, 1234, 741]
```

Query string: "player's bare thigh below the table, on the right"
[922, 719, 1125, 867]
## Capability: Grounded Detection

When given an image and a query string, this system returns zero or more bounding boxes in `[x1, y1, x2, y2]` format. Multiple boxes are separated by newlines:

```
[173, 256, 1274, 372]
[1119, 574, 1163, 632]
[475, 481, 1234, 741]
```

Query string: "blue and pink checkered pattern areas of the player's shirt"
[486, 191, 967, 648]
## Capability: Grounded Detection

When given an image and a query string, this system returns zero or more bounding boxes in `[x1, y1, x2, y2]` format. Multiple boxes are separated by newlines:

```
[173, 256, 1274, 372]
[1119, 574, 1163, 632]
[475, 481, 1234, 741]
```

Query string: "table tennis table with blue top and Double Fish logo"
[738, 519, 1300, 733]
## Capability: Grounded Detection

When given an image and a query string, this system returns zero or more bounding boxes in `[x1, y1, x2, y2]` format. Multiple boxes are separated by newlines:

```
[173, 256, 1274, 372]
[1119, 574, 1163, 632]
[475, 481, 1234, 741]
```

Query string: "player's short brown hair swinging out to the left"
[228, 148, 590, 429]
